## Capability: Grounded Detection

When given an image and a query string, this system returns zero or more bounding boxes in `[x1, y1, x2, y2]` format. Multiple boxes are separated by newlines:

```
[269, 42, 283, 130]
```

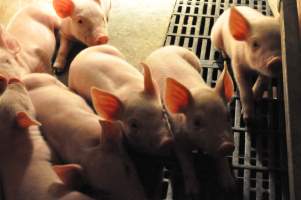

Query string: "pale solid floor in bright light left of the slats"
[0, 0, 175, 66]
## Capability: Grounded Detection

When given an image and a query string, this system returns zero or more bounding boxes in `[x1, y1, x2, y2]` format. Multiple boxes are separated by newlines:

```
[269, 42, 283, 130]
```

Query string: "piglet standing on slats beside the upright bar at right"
[211, 6, 281, 123]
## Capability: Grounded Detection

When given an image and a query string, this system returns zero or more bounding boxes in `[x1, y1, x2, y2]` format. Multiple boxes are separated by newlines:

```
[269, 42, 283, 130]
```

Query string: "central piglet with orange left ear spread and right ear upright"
[69, 45, 172, 198]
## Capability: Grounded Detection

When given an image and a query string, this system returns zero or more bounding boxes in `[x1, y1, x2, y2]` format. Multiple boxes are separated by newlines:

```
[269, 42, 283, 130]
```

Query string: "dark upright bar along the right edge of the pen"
[280, 0, 301, 200]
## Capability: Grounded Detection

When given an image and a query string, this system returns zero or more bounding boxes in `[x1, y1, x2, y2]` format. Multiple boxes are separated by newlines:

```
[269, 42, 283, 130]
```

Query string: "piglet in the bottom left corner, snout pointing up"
[0, 76, 92, 200]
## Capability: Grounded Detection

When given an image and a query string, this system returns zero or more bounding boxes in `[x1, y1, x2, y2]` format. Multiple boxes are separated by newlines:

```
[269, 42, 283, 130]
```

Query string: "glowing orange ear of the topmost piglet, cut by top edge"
[53, 0, 74, 18]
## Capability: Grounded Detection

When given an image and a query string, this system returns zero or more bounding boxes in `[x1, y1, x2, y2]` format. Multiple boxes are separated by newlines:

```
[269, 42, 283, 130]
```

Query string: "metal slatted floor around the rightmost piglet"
[164, 0, 288, 200]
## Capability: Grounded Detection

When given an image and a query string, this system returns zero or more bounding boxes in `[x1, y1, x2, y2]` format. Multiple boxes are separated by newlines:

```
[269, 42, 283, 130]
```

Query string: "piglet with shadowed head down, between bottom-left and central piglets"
[23, 74, 145, 200]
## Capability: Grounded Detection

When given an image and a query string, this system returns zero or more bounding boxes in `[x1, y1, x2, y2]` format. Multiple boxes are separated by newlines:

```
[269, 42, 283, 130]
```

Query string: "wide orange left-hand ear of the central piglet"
[91, 87, 123, 120]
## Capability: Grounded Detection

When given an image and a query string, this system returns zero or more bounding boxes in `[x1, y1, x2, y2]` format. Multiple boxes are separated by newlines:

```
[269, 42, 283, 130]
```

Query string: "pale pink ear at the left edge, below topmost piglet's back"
[0, 27, 21, 54]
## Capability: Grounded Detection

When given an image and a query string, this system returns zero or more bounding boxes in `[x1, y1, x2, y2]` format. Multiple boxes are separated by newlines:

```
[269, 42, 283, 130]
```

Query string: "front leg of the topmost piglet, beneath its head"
[53, 34, 72, 74]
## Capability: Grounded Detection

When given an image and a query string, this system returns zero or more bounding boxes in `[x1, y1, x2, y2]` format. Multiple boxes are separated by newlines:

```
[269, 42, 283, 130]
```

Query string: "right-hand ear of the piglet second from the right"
[215, 62, 234, 103]
